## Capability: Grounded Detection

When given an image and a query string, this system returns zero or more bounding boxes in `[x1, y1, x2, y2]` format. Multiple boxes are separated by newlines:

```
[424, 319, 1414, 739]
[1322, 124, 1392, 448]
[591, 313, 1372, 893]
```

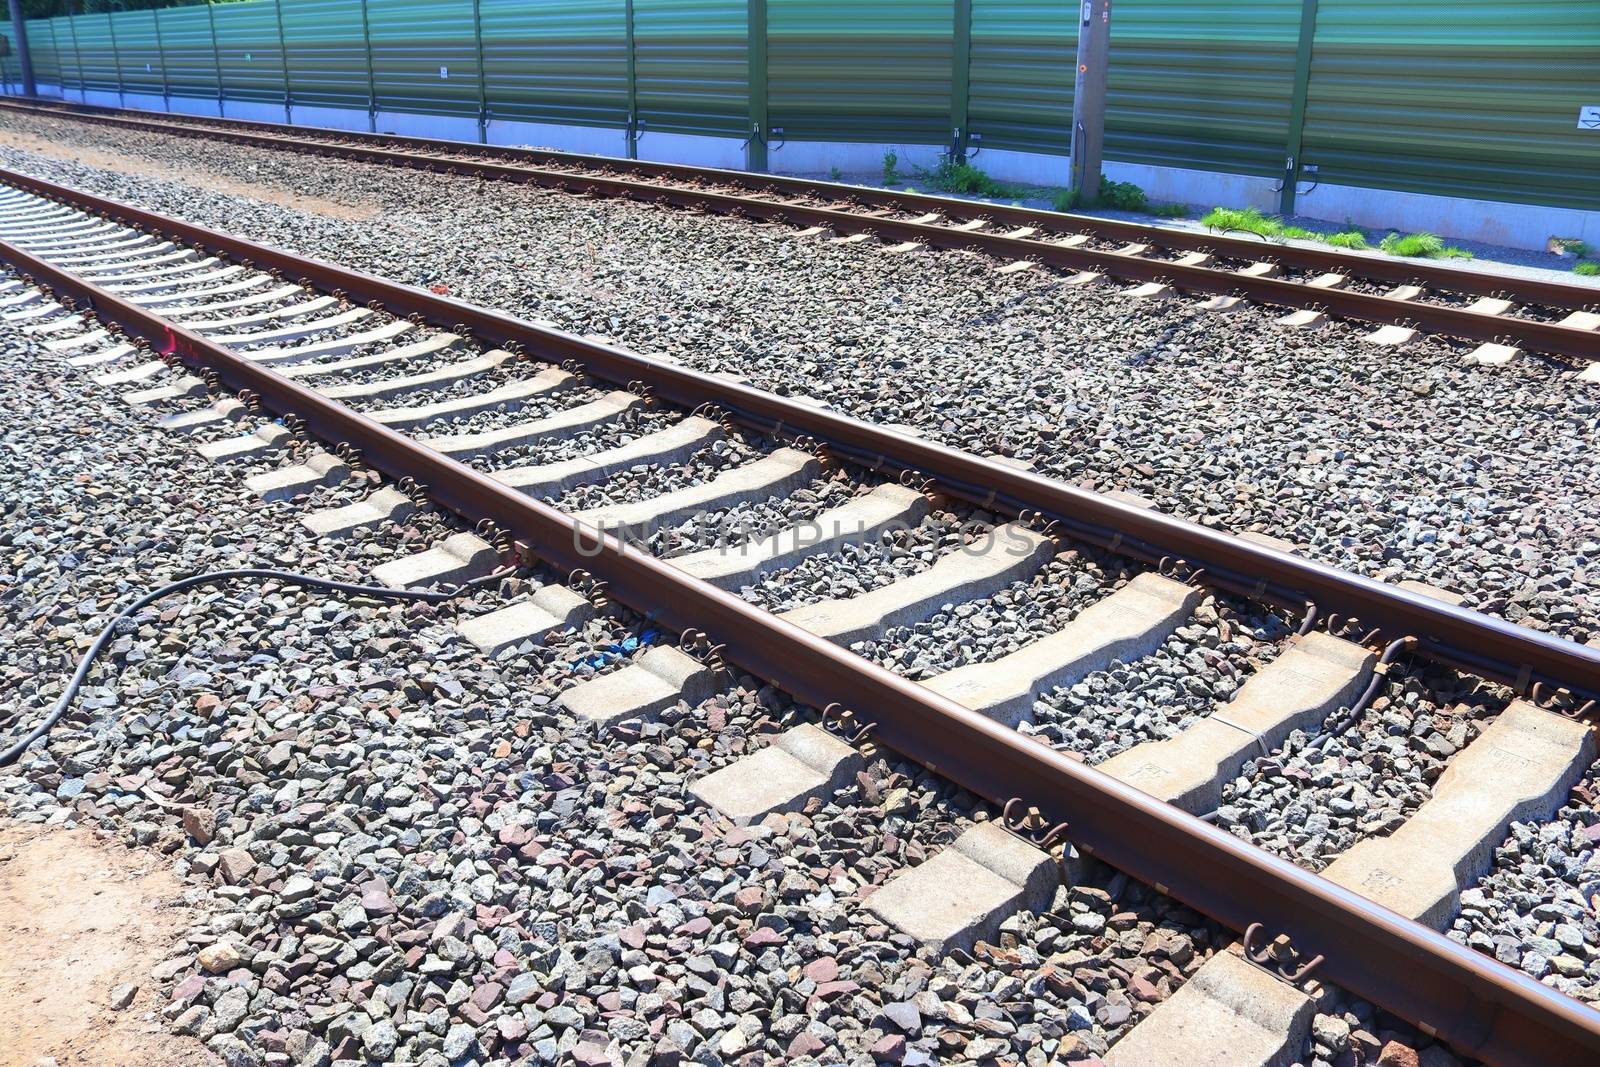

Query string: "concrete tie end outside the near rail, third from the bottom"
[688, 723, 866, 825]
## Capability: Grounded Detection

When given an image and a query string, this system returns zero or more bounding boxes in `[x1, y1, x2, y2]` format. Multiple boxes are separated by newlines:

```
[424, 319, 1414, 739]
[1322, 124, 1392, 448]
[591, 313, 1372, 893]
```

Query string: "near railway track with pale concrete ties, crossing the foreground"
[0, 173, 1600, 1064]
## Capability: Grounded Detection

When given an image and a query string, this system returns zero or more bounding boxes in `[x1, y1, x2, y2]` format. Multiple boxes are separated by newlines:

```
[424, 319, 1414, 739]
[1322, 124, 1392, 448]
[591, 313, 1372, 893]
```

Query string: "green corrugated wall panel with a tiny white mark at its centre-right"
[366, 0, 478, 115]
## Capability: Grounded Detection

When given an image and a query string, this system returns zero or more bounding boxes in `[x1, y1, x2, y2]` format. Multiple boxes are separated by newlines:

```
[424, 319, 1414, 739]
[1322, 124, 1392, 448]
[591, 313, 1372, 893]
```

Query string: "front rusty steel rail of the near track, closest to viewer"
[0, 217, 1600, 1067]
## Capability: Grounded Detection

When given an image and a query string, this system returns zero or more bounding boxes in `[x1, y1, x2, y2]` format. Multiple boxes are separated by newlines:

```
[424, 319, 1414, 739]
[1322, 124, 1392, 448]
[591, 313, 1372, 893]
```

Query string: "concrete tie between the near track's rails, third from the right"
[923, 571, 1202, 726]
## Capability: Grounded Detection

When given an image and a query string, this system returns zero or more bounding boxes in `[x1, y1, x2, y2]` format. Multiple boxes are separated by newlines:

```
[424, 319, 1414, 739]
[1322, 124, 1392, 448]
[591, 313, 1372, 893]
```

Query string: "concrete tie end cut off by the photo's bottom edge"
[1101, 950, 1317, 1067]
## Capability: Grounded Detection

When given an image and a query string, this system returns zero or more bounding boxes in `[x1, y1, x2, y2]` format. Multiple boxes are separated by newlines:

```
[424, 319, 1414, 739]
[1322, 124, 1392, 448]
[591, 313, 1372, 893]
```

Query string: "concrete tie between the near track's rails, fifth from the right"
[667, 483, 928, 589]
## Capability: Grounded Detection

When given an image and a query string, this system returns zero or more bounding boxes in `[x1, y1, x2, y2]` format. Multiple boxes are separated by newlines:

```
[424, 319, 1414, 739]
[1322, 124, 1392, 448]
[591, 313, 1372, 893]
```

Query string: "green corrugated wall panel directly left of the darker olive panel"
[634, 0, 749, 136]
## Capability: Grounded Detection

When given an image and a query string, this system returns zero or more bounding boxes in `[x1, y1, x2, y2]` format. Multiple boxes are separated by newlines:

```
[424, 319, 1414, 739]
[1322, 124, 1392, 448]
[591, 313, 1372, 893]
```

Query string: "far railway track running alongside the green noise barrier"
[9, 101, 1600, 373]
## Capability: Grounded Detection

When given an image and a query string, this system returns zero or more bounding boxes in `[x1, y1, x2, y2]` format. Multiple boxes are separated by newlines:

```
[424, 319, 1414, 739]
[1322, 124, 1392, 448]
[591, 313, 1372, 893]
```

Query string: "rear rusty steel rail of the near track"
[0, 168, 1600, 710]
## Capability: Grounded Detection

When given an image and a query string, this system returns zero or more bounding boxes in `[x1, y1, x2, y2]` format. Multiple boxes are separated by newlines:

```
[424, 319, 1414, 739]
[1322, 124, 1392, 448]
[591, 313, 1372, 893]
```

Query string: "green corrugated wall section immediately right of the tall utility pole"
[1106, 0, 1301, 176]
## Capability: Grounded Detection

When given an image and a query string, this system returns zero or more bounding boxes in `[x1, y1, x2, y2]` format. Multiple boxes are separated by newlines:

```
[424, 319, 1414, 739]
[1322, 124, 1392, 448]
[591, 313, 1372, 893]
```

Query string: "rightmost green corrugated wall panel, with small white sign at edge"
[1302, 0, 1600, 211]
